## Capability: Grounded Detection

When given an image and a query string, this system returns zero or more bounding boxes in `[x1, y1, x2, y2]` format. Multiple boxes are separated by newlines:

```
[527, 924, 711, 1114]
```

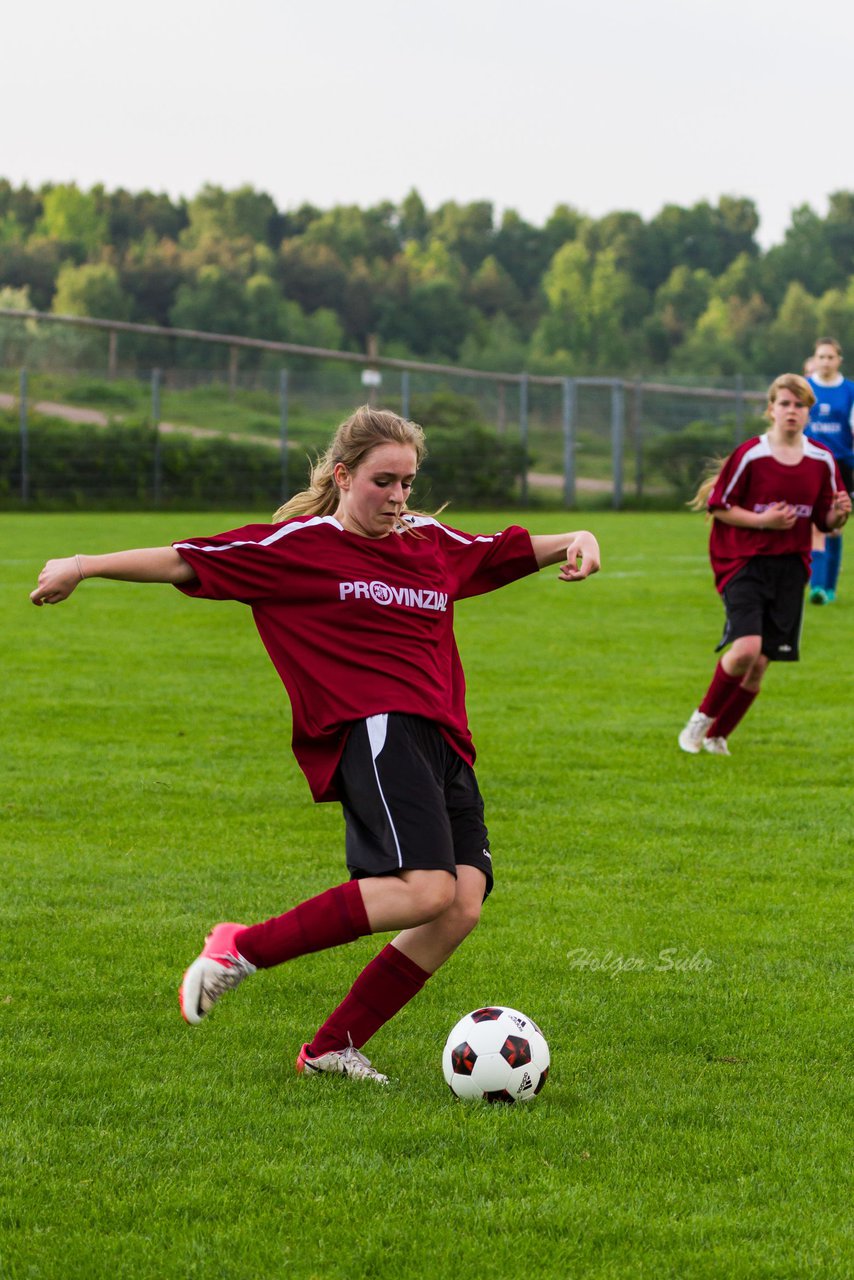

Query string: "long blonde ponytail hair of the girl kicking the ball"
[273, 404, 426, 527]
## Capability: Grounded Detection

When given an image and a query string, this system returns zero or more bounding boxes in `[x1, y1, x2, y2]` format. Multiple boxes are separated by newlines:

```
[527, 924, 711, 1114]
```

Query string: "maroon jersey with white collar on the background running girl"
[708, 433, 842, 591]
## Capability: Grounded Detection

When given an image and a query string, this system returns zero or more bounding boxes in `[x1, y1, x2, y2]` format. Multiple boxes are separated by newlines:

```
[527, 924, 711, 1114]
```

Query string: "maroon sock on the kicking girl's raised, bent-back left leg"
[234, 881, 373, 969]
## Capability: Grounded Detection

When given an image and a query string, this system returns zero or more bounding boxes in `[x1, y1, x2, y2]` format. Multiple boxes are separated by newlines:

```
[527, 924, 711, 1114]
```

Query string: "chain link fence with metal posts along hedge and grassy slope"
[0, 310, 764, 508]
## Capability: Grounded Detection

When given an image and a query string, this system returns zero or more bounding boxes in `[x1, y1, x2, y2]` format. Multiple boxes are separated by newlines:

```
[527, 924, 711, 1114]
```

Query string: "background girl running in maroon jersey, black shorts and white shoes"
[679, 374, 851, 755]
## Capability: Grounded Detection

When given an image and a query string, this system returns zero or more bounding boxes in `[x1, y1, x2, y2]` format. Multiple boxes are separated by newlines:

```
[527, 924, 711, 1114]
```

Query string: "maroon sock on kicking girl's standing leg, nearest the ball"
[310, 942, 430, 1057]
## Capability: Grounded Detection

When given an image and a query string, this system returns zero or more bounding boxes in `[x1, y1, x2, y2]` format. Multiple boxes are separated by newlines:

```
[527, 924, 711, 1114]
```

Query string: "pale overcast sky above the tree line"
[0, 0, 854, 248]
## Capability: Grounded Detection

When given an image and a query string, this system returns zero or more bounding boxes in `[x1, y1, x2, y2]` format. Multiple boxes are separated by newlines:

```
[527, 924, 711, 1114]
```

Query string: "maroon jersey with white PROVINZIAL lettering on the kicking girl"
[173, 516, 538, 800]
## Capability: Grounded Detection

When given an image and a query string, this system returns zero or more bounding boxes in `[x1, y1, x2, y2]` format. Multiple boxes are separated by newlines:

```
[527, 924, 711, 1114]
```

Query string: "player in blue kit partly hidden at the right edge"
[804, 338, 854, 604]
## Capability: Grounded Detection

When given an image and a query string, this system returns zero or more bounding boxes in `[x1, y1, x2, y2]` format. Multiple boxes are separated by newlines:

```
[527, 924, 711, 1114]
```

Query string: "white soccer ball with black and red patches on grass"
[442, 1005, 549, 1102]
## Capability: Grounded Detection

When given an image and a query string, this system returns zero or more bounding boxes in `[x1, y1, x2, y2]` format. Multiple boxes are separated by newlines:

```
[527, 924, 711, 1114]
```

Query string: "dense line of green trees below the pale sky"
[0, 179, 854, 376]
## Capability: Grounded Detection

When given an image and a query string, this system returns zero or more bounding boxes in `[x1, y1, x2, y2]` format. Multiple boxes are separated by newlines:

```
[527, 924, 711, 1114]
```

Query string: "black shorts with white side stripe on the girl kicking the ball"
[335, 712, 493, 897]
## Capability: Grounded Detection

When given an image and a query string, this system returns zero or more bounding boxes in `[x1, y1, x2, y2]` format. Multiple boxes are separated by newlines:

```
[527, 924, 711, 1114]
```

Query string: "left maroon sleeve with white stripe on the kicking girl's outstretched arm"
[172, 525, 290, 604]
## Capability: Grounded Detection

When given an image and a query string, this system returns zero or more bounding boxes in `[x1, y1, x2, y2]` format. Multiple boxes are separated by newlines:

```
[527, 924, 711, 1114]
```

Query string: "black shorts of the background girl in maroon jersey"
[714, 556, 808, 662]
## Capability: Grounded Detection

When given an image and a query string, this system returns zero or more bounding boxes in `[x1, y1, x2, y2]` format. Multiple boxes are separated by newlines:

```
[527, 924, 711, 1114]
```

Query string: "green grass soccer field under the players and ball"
[0, 513, 854, 1280]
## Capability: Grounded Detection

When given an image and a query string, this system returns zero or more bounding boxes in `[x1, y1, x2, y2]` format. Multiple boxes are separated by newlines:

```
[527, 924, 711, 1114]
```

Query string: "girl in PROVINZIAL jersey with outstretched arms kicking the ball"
[31, 407, 599, 1084]
